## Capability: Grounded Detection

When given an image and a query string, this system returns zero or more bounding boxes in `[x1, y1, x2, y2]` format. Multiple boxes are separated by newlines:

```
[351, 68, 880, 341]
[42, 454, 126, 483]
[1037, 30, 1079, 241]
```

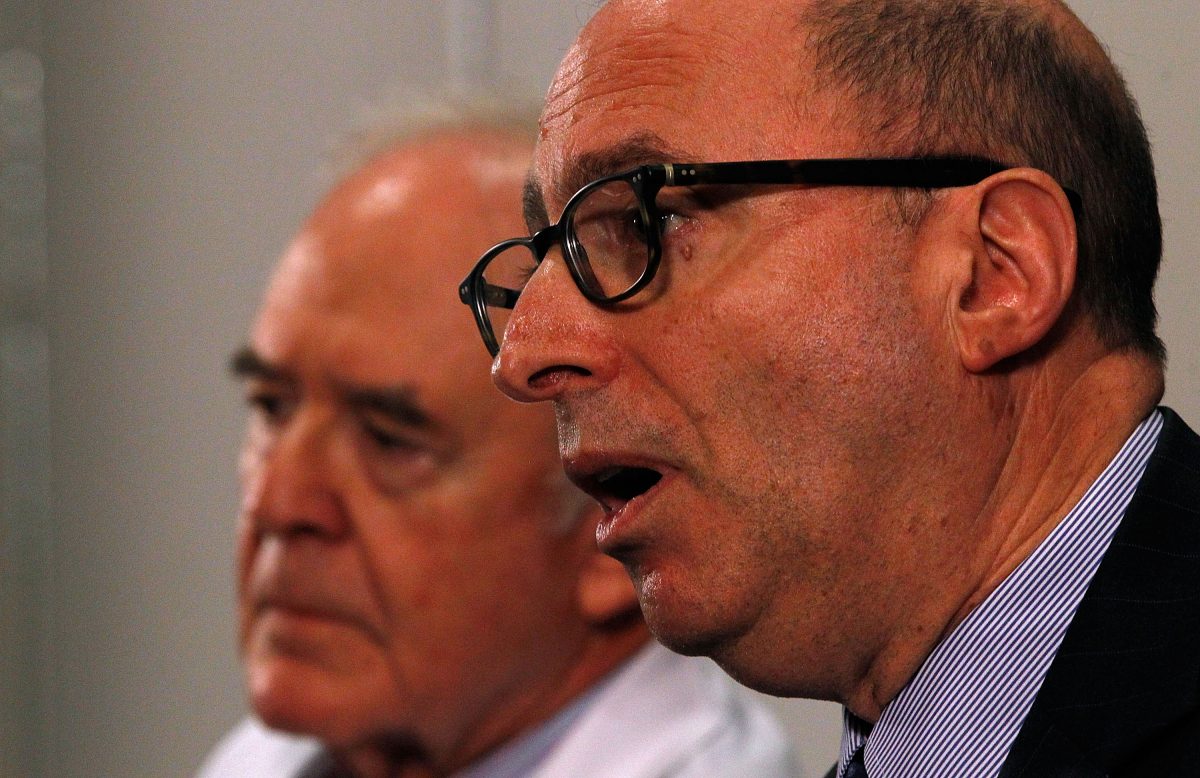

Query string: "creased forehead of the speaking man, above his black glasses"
[534, 0, 850, 210]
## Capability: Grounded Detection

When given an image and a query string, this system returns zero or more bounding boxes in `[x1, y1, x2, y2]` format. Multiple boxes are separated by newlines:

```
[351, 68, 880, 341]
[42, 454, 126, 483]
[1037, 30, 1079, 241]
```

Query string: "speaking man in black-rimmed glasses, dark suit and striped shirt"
[460, 0, 1200, 778]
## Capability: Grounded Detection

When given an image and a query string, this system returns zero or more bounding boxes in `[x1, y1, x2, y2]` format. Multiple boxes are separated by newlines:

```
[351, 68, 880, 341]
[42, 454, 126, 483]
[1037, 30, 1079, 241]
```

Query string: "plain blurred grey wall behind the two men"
[0, 0, 1200, 777]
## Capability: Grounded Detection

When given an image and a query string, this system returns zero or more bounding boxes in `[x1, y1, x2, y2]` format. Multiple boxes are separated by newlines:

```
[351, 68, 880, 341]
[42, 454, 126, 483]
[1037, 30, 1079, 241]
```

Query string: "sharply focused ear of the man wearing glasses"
[949, 168, 1076, 372]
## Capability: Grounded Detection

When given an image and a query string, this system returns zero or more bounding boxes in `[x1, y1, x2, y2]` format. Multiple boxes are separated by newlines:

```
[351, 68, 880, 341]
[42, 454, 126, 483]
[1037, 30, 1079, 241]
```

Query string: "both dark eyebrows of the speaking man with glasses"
[522, 131, 690, 226]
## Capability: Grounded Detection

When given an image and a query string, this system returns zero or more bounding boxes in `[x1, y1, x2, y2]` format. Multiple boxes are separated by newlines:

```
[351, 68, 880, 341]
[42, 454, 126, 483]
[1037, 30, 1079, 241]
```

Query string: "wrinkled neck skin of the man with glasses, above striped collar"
[842, 347, 1163, 723]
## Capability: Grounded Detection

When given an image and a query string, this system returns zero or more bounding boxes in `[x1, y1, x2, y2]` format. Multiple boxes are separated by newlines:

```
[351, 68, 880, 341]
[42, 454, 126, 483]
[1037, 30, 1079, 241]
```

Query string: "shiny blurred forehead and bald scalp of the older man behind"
[252, 139, 528, 420]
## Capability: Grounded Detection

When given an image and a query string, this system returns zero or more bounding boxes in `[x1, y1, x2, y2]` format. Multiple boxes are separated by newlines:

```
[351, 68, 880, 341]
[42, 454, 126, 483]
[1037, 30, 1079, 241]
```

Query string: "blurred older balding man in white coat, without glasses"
[200, 117, 794, 778]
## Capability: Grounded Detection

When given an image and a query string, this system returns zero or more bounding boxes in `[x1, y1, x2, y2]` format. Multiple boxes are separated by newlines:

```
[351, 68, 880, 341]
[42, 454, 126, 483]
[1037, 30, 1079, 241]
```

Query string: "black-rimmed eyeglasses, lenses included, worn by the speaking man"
[458, 156, 1080, 357]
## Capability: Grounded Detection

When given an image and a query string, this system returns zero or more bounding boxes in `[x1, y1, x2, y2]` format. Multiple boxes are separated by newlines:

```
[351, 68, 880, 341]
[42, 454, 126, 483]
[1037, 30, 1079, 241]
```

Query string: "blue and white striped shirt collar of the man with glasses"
[838, 411, 1163, 778]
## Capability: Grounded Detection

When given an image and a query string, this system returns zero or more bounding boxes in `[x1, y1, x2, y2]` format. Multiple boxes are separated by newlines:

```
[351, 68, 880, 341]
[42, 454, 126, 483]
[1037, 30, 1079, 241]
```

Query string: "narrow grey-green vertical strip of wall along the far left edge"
[0, 0, 49, 774]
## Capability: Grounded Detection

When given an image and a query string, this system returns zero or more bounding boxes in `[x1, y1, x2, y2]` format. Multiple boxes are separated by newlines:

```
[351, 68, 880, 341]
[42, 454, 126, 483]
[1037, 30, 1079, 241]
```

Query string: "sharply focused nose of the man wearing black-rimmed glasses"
[492, 251, 620, 402]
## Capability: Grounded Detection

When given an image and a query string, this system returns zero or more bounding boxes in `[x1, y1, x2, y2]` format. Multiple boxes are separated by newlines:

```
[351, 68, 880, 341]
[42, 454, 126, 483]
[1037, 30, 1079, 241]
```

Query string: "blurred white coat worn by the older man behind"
[197, 644, 798, 778]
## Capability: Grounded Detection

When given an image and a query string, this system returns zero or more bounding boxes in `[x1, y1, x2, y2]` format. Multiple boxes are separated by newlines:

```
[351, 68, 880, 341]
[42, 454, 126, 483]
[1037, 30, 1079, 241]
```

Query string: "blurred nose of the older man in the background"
[241, 412, 348, 539]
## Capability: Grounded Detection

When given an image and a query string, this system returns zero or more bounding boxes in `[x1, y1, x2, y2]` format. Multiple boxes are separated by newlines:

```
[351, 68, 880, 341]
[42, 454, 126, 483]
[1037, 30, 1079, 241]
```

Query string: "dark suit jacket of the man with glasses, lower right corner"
[829, 408, 1200, 778]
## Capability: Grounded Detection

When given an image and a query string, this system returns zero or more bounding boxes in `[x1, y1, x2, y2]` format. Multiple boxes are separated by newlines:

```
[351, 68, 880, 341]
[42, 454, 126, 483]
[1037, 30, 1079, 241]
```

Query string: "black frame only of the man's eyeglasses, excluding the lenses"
[458, 156, 1082, 358]
